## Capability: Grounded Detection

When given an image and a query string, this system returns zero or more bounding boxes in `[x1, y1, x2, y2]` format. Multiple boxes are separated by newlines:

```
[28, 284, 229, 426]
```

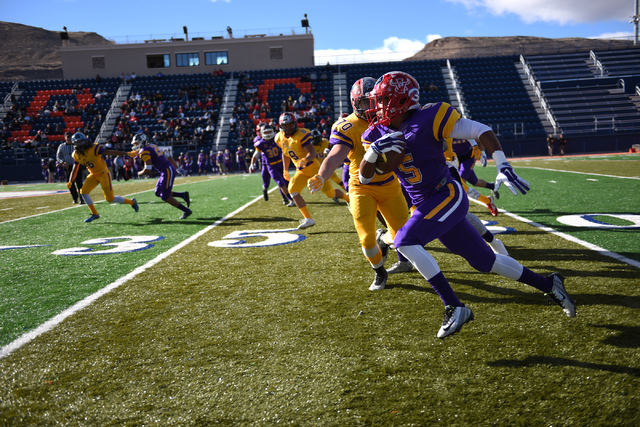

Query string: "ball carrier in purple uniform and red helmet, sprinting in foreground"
[360, 72, 576, 338]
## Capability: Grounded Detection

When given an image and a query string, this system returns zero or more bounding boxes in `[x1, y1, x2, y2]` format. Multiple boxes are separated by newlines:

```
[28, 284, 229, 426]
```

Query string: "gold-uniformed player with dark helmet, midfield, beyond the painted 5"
[275, 113, 349, 229]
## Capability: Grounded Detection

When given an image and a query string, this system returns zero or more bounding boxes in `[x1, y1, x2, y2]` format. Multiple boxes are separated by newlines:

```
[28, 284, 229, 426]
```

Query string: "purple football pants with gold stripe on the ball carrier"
[394, 181, 496, 272]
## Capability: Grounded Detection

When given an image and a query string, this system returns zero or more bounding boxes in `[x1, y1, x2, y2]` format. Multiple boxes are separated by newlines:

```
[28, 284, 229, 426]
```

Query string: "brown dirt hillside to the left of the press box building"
[0, 21, 111, 81]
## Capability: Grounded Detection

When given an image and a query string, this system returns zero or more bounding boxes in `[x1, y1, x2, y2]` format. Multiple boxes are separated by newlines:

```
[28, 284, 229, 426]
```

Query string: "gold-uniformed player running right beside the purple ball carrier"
[309, 77, 409, 291]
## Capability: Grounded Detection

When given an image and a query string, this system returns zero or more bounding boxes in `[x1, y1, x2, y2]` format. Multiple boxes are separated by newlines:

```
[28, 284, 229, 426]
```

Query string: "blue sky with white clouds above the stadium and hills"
[0, 0, 635, 64]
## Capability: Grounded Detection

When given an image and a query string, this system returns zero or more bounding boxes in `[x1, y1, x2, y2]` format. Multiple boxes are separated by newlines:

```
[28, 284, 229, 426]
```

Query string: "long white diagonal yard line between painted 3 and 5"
[0, 195, 264, 359]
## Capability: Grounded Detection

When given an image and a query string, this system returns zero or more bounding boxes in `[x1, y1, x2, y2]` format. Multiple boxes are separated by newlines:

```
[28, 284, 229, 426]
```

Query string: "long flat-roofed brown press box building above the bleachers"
[60, 32, 314, 79]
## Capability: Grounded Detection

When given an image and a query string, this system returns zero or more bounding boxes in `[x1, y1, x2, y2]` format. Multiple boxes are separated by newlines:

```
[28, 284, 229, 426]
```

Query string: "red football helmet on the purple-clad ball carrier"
[366, 71, 420, 126]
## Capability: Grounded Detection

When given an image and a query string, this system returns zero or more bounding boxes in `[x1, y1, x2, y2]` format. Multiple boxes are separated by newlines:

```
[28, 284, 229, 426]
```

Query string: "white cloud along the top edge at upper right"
[447, 0, 633, 25]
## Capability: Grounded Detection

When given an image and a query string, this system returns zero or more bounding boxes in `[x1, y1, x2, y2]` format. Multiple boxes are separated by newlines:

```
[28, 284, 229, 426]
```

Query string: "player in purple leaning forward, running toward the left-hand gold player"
[131, 133, 193, 219]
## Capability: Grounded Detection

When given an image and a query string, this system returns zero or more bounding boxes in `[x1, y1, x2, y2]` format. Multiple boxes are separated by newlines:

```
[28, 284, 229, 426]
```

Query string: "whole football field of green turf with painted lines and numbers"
[0, 154, 640, 426]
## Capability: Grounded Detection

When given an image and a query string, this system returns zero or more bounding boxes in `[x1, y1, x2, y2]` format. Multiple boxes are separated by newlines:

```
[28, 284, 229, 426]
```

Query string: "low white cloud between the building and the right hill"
[315, 34, 441, 65]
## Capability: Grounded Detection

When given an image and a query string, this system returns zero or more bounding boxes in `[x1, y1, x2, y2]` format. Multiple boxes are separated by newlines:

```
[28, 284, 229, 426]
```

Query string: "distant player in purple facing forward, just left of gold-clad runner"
[251, 125, 296, 207]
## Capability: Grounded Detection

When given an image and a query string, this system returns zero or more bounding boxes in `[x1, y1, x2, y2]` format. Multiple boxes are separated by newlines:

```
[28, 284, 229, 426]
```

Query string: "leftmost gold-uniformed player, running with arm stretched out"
[67, 132, 138, 222]
